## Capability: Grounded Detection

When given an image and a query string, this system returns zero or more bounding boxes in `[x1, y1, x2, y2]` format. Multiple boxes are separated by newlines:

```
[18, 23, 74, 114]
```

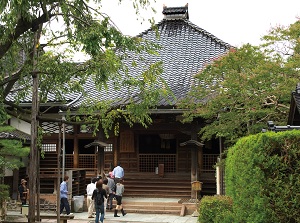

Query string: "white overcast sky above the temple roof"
[101, 0, 300, 47]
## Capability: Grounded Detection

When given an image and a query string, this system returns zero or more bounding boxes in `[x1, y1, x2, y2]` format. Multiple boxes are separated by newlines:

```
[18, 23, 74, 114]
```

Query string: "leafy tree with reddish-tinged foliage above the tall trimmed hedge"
[181, 19, 300, 145]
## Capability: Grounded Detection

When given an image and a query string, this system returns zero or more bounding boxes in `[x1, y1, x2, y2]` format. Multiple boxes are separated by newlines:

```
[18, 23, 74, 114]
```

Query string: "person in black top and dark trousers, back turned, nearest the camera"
[92, 180, 107, 223]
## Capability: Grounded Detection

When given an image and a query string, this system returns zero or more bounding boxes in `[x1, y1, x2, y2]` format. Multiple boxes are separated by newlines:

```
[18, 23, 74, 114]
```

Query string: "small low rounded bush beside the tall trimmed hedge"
[198, 196, 232, 223]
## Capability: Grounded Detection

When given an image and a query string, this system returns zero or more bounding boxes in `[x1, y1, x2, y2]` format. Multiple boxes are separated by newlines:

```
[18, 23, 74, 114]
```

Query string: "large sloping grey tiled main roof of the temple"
[71, 18, 231, 108]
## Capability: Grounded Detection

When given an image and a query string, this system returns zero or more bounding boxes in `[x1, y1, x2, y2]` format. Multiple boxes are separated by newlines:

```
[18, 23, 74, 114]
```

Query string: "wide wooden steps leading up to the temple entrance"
[114, 173, 216, 216]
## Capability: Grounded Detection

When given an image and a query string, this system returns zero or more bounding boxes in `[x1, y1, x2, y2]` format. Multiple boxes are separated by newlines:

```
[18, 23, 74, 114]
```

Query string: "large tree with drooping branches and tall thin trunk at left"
[0, 0, 168, 222]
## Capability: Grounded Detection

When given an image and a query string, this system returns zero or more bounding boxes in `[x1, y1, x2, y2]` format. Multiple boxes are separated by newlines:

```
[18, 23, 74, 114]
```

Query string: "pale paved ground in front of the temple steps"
[7, 211, 198, 223]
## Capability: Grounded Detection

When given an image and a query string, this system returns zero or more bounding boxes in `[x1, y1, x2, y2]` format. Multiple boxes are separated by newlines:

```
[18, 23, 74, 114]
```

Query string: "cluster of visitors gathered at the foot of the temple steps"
[86, 164, 126, 223]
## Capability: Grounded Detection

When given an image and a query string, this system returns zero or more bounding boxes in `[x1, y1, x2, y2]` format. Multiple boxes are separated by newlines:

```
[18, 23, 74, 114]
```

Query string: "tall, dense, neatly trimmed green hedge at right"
[225, 130, 300, 223]
